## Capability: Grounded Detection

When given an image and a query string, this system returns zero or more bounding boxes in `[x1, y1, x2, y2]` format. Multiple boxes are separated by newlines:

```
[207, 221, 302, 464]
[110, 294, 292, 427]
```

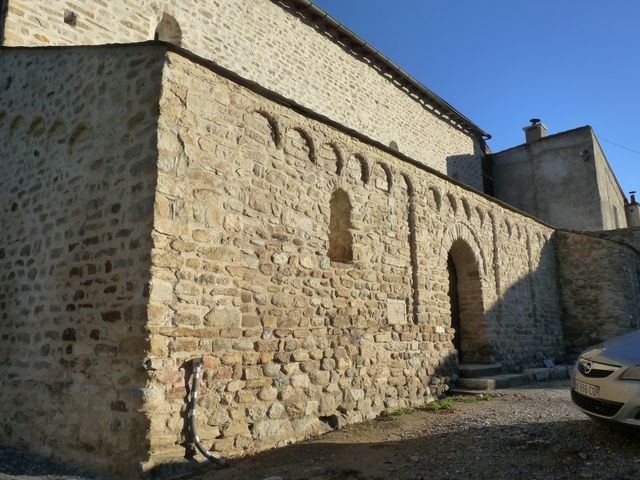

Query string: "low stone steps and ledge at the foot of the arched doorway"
[451, 365, 572, 393]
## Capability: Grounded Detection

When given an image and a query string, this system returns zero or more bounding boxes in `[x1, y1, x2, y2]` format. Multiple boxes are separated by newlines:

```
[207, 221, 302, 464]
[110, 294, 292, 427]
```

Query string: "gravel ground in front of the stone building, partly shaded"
[0, 380, 640, 480]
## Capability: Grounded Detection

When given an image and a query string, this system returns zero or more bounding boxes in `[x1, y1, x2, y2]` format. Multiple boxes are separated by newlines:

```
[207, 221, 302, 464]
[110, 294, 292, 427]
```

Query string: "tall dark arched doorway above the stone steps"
[447, 239, 494, 363]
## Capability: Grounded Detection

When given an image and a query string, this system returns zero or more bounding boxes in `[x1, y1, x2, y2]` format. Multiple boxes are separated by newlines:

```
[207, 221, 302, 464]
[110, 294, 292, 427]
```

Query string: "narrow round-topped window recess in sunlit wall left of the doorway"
[327, 189, 353, 263]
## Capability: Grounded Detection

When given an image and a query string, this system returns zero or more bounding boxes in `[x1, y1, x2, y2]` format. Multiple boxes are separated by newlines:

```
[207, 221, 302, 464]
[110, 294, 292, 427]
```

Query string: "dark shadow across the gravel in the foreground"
[192, 414, 640, 480]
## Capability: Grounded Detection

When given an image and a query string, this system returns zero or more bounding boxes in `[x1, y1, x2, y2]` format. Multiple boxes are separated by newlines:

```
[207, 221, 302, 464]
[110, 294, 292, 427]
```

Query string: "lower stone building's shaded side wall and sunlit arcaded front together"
[0, 45, 563, 478]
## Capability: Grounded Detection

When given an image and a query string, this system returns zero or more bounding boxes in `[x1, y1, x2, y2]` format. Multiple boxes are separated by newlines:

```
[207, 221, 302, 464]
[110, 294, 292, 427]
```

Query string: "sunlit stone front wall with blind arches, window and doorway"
[142, 53, 562, 463]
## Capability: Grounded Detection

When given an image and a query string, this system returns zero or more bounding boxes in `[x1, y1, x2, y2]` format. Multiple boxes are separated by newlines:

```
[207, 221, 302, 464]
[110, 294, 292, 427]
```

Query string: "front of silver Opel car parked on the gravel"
[571, 330, 640, 427]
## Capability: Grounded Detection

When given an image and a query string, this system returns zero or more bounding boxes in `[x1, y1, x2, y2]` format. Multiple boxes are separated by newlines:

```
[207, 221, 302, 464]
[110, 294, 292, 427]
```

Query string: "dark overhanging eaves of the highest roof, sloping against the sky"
[271, 0, 491, 140]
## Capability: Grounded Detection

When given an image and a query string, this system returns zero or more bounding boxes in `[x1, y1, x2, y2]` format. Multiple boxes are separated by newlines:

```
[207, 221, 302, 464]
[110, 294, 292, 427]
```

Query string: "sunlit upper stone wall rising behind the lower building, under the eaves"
[4, 0, 483, 190]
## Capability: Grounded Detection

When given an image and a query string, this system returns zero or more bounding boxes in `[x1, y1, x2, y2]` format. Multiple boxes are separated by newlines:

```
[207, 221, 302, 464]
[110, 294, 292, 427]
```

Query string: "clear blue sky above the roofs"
[315, 0, 640, 197]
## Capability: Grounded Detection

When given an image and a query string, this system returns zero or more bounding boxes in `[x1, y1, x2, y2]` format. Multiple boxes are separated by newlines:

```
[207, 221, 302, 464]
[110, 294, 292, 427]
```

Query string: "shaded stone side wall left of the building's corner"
[0, 47, 163, 473]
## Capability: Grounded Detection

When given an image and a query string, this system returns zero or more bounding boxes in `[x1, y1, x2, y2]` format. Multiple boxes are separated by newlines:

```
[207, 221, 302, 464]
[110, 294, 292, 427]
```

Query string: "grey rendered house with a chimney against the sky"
[491, 119, 628, 230]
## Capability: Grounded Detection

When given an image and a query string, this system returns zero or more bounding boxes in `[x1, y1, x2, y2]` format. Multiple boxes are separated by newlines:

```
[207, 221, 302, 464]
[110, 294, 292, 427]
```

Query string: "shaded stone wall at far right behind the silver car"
[557, 231, 640, 354]
